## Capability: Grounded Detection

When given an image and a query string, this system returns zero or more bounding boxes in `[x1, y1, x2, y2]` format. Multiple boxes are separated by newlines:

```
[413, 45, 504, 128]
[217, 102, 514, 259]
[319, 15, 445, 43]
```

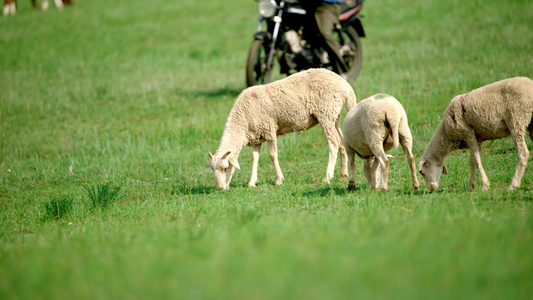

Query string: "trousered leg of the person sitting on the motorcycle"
[315, 2, 348, 74]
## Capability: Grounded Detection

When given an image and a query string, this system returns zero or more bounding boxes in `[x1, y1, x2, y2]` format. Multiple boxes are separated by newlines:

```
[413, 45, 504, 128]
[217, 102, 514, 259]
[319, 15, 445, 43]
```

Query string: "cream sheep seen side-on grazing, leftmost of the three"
[208, 69, 356, 189]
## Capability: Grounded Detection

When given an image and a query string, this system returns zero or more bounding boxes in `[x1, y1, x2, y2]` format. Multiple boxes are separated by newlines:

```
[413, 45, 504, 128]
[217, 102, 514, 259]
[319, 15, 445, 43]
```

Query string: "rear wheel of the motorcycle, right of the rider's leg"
[341, 25, 363, 79]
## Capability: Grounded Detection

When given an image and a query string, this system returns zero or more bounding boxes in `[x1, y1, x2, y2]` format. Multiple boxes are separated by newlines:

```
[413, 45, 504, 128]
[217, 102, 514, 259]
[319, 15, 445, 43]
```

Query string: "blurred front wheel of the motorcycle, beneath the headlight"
[246, 39, 272, 87]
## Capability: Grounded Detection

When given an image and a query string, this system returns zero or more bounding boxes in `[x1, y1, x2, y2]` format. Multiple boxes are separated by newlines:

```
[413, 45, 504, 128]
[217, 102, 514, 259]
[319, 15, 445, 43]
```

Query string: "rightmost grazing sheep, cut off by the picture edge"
[418, 77, 533, 191]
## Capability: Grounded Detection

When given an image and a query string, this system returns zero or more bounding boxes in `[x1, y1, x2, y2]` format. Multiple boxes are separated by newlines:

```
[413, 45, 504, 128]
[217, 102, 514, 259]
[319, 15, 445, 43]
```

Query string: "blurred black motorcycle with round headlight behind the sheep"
[246, 0, 365, 86]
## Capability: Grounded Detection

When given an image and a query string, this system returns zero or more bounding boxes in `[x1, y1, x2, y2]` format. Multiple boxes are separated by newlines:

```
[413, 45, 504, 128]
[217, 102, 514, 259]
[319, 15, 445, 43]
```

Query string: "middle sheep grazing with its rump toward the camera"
[342, 94, 420, 190]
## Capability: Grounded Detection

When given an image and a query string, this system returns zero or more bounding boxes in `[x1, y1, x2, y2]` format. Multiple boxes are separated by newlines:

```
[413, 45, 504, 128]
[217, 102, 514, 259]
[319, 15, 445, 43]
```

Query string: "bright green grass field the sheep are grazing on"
[0, 0, 533, 299]
